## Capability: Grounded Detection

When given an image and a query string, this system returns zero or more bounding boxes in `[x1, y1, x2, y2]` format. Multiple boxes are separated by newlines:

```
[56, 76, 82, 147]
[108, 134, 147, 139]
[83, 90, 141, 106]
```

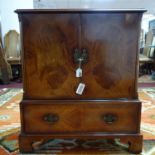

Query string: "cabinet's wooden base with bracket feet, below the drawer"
[19, 133, 143, 154]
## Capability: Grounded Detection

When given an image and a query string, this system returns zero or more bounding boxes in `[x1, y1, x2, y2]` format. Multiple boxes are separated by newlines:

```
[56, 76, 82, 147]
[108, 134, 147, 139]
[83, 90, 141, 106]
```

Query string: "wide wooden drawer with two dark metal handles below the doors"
[22, 101, 141, 133]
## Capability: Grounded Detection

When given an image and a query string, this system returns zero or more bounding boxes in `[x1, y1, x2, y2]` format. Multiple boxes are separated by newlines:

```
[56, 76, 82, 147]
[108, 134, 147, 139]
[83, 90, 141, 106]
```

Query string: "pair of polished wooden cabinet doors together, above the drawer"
[21, 12, 141, 99]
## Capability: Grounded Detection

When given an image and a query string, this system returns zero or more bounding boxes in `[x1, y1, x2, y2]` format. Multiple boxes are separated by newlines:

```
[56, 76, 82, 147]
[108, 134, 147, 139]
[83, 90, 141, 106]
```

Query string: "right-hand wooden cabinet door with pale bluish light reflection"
[81, 13, 141, 98]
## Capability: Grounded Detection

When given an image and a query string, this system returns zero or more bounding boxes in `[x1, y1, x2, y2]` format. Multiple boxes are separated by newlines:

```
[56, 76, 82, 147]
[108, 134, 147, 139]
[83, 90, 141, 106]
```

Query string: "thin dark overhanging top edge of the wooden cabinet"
[15, 9, 147, 13]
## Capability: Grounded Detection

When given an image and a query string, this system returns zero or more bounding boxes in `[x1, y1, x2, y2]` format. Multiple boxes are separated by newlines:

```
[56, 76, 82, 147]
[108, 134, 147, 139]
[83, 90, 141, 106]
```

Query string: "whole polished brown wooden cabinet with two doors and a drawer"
[16, 9, 145, 153]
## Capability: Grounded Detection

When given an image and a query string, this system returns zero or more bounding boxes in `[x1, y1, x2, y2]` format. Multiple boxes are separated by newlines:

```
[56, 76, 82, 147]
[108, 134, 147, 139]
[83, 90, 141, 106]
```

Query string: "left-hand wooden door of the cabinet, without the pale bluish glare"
[22, 13, 80, 99]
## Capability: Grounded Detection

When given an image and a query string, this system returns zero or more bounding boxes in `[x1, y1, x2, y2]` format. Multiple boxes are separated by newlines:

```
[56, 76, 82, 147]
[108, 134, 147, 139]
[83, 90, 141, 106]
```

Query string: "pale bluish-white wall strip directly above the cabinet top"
[33, 0, 155, 14]
